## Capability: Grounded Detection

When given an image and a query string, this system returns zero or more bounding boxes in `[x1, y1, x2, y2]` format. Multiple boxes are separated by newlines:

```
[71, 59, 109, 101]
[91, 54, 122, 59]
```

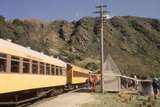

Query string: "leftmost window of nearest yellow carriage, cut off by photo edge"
[0, 53, 6, 72]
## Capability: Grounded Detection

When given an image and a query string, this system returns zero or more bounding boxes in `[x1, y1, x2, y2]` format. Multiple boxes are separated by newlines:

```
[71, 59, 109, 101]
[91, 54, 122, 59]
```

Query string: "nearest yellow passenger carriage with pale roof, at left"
[0, 39, 67, 104]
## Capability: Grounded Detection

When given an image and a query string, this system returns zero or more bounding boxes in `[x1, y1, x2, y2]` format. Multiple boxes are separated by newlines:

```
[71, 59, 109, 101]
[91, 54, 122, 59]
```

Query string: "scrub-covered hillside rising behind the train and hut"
[0, 16, 160, 76]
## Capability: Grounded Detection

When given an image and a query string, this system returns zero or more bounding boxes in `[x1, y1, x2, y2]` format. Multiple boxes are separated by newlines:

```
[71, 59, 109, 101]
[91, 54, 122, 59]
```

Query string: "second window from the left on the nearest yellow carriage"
[11, 56, 20, 73]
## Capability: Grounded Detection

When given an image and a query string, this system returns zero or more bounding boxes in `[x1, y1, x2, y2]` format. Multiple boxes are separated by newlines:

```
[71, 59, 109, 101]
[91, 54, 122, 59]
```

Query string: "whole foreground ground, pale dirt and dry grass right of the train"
[29, 89, 160, 107]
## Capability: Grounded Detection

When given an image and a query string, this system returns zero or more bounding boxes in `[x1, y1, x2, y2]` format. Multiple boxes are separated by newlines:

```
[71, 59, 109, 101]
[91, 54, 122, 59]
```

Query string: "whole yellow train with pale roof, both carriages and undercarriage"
[0, 39, 91, 104]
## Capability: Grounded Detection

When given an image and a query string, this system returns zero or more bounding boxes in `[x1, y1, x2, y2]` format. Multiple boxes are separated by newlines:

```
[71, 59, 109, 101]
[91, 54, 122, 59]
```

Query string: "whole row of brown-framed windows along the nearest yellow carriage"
[0, 53, 65, 76]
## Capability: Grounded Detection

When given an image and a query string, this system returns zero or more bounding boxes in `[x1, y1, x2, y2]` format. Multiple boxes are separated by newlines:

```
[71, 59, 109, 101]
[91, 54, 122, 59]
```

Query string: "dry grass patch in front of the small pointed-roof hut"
[81, 93, 160, 107]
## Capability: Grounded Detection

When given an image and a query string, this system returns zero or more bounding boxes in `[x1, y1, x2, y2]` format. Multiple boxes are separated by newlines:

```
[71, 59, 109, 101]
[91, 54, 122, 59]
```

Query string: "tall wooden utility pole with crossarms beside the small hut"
[95, 3, 107, 93]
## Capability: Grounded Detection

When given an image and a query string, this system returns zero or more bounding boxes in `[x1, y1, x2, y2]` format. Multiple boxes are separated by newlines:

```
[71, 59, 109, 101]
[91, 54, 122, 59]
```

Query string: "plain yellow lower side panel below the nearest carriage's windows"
[0, 73, 66, 94]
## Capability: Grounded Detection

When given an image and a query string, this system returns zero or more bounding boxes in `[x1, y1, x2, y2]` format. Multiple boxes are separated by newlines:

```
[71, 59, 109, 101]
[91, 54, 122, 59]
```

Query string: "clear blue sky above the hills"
[0, 0, 160, 20]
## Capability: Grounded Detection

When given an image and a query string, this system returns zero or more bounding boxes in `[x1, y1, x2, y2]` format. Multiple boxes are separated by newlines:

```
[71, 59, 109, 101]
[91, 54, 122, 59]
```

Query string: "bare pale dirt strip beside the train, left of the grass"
[29, 90, 95, 107]
